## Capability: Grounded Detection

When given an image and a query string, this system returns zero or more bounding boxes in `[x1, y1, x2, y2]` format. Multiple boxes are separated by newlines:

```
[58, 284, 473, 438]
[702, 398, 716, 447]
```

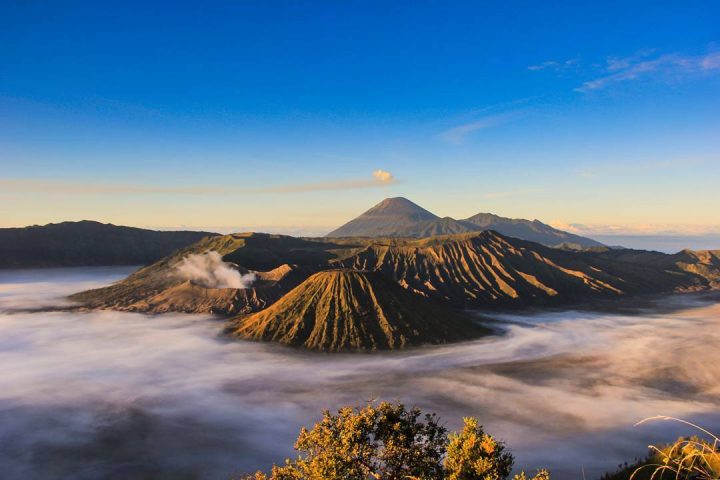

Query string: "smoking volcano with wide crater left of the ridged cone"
[70, 233, 331, 315]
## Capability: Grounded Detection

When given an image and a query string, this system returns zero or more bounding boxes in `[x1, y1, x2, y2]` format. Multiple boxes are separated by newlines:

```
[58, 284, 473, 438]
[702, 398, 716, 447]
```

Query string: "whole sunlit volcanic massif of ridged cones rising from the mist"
[71, 231, 720, 351]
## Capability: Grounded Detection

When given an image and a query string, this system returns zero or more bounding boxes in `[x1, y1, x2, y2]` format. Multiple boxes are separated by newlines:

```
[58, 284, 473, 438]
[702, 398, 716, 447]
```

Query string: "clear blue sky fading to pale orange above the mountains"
[0, 1, 720, 244]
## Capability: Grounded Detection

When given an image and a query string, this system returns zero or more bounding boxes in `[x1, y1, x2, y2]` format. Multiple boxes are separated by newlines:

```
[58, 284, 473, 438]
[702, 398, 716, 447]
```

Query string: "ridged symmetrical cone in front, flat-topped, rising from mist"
[229, 270, 486, 351]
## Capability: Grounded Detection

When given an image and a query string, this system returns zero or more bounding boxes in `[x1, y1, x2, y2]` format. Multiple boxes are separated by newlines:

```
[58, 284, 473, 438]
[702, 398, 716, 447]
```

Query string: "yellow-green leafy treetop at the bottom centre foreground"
[246, 402, 550, 480]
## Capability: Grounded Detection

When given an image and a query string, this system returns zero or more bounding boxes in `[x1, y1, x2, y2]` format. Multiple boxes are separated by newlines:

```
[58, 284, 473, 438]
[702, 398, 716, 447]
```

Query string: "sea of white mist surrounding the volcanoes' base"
[0, 269, 720, 480]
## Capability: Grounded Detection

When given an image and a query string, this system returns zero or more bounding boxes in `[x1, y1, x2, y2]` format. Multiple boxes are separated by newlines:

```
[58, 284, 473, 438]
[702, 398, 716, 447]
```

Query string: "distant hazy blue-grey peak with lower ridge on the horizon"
[326, 197, 603, 248]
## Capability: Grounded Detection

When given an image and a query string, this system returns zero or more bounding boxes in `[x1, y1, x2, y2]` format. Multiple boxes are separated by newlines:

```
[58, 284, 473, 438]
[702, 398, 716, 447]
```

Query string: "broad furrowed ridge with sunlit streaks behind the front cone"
[342, 231, 710, 306]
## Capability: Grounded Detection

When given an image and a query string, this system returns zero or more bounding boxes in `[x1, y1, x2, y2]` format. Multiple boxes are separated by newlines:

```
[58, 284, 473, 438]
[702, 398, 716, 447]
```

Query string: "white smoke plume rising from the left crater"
[176, 251, 255, 288]
